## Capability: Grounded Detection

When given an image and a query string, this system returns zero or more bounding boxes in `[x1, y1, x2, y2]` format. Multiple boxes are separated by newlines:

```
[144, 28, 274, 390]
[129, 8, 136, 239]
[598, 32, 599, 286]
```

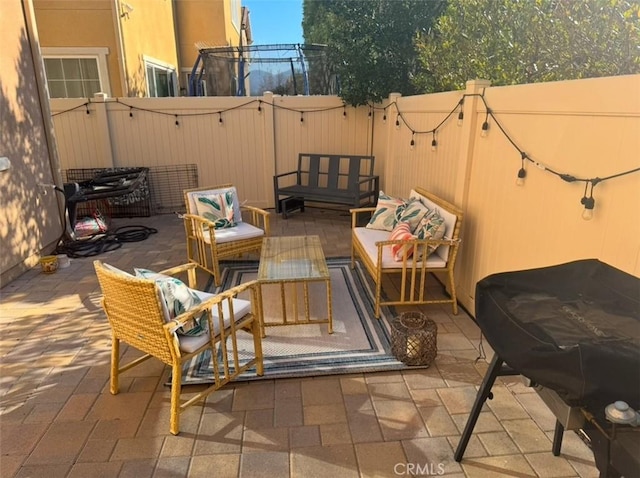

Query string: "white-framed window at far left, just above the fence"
[42, 48, 111, 98]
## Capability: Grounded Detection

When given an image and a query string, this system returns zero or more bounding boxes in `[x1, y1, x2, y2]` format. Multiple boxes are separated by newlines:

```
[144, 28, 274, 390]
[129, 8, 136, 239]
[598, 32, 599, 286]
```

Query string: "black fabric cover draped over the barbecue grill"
[476, 259, 640, 410]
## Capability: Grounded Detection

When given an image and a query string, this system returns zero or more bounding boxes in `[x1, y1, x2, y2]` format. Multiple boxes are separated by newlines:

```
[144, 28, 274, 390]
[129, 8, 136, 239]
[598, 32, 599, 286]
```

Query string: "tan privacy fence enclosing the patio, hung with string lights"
[51, 75, 640, 311]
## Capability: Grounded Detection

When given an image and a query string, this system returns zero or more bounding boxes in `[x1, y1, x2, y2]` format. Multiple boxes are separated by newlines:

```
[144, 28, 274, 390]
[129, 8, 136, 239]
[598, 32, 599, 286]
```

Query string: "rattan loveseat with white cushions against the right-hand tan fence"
[351, 188, 462, 317]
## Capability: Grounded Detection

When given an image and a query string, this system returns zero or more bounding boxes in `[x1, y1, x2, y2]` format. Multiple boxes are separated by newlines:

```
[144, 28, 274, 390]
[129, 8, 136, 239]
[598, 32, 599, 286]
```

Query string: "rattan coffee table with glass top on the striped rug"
[258, 236, 333, 337]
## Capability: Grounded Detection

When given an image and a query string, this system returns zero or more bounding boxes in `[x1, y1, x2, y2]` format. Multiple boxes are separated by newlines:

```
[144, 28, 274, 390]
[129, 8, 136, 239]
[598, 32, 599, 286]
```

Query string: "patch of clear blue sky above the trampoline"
[242, 0, 304, 45]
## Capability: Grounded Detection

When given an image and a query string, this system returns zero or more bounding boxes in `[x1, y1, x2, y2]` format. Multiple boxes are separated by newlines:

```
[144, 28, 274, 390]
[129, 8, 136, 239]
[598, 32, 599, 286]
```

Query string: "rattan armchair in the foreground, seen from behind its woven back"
[94, 261, 263, 435]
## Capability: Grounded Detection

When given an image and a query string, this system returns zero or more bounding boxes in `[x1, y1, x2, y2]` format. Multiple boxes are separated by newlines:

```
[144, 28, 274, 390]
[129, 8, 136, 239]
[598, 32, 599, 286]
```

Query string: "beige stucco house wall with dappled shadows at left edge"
[0, 0, 62, 285]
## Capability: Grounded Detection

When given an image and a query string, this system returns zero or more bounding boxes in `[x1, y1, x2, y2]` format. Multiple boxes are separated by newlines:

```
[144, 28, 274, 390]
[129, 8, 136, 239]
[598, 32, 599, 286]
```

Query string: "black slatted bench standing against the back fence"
[273, 153, 380, 218]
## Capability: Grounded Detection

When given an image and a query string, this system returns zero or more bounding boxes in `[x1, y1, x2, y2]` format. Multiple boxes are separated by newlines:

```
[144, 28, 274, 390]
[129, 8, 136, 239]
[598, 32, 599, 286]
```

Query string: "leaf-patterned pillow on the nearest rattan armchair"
[134, 268, 207, 336]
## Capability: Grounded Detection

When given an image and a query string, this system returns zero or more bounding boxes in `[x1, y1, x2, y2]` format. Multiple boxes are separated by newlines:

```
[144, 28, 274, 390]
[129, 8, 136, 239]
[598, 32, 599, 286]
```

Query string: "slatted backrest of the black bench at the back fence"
[298, 153, 374, 190]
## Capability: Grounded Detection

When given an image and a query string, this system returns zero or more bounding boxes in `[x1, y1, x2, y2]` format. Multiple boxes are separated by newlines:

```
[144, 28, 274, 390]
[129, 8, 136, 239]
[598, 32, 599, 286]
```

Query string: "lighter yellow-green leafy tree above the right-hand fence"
[414, 0, 640, 92]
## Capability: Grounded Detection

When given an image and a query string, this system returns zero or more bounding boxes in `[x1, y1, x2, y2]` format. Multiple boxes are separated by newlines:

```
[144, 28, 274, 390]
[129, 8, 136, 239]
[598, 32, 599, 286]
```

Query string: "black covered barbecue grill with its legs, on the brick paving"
[455, 259, 640, 477]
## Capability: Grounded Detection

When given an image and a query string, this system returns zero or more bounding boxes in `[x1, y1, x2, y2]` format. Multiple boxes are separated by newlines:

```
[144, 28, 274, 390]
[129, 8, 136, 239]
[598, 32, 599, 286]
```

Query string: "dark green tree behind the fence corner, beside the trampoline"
[302, 0, 446, 105]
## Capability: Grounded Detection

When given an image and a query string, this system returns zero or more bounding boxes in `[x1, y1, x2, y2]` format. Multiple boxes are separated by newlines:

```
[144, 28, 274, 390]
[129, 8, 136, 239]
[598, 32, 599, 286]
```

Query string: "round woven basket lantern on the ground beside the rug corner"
[391, 312, 438, 366]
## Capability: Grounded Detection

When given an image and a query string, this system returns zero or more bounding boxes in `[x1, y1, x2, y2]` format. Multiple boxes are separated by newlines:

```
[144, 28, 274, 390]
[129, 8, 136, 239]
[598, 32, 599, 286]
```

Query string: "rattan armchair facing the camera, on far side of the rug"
[184, 184, 269, 286]
